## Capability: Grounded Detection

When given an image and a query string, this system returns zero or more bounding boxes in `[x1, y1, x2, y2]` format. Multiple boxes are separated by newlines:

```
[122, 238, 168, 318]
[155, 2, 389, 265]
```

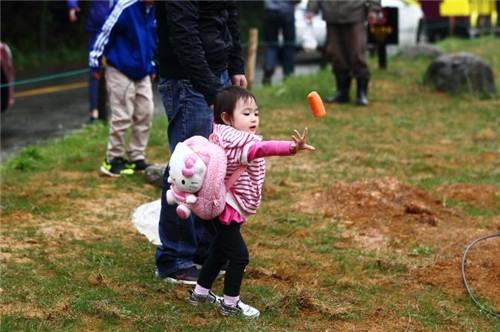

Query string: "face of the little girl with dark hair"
[222, 98, 259, 134]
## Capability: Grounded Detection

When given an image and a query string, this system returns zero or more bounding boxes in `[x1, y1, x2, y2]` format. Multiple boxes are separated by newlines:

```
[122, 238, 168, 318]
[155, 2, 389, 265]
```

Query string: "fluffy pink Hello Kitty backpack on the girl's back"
[166, 136, 246, 220]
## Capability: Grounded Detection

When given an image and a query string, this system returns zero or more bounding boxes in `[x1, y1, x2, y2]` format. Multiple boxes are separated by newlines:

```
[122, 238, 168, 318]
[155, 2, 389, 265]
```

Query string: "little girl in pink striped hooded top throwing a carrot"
[189, 86, 314, 318]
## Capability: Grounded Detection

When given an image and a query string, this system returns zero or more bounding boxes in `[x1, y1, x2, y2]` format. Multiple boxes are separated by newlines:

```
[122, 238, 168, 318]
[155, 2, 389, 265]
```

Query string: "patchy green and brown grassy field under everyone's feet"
[0, 37, 500, 331]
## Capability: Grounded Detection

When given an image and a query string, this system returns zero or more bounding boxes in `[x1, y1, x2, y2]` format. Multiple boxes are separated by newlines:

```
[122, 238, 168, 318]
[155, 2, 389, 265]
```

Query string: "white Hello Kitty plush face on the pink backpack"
[168, 143, 207, 193]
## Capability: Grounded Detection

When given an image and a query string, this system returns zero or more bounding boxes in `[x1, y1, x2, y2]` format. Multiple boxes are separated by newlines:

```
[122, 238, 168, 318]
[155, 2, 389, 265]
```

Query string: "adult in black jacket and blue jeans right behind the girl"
[155, 1, 247, 285]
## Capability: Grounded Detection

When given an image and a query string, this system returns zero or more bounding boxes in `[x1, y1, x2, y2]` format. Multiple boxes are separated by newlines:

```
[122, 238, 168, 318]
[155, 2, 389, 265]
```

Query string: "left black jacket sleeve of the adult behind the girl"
[166, 1, 223, 105]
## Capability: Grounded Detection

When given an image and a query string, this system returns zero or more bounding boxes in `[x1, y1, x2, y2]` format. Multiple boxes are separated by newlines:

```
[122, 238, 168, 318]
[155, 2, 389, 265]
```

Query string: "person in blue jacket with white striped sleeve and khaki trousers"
[89, 0, 157, 177]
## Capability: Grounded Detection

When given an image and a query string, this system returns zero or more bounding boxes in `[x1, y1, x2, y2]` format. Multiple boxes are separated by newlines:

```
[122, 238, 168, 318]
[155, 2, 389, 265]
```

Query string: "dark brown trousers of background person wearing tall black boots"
[326, 23, 370, 79]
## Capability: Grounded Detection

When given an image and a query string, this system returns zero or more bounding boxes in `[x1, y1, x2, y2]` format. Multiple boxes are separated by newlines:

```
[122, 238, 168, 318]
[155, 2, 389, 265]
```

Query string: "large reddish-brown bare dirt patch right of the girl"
[299, 178, 500, 310]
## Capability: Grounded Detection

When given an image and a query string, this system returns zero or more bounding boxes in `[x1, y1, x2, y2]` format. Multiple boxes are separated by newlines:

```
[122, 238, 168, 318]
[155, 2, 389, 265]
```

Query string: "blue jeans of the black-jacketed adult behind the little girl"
[156, 72, 231, 277]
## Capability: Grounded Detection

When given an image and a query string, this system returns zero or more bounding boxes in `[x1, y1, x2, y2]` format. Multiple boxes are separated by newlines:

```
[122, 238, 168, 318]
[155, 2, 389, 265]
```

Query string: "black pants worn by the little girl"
[198, 219, 249, 296]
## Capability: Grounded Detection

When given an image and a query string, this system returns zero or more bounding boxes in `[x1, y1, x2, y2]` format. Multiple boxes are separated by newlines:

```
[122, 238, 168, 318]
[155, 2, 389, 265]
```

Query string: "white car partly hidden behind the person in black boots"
[295, 0, 425, 52]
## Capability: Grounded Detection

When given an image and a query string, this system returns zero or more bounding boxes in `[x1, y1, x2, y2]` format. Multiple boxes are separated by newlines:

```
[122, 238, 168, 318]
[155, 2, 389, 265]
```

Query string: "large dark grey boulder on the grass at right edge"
[424, 52, 497, 98]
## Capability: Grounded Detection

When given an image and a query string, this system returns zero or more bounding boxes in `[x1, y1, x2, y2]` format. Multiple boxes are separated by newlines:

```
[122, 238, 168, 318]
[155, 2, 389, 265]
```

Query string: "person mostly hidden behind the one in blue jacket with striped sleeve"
[67, 0, 116, 124]
